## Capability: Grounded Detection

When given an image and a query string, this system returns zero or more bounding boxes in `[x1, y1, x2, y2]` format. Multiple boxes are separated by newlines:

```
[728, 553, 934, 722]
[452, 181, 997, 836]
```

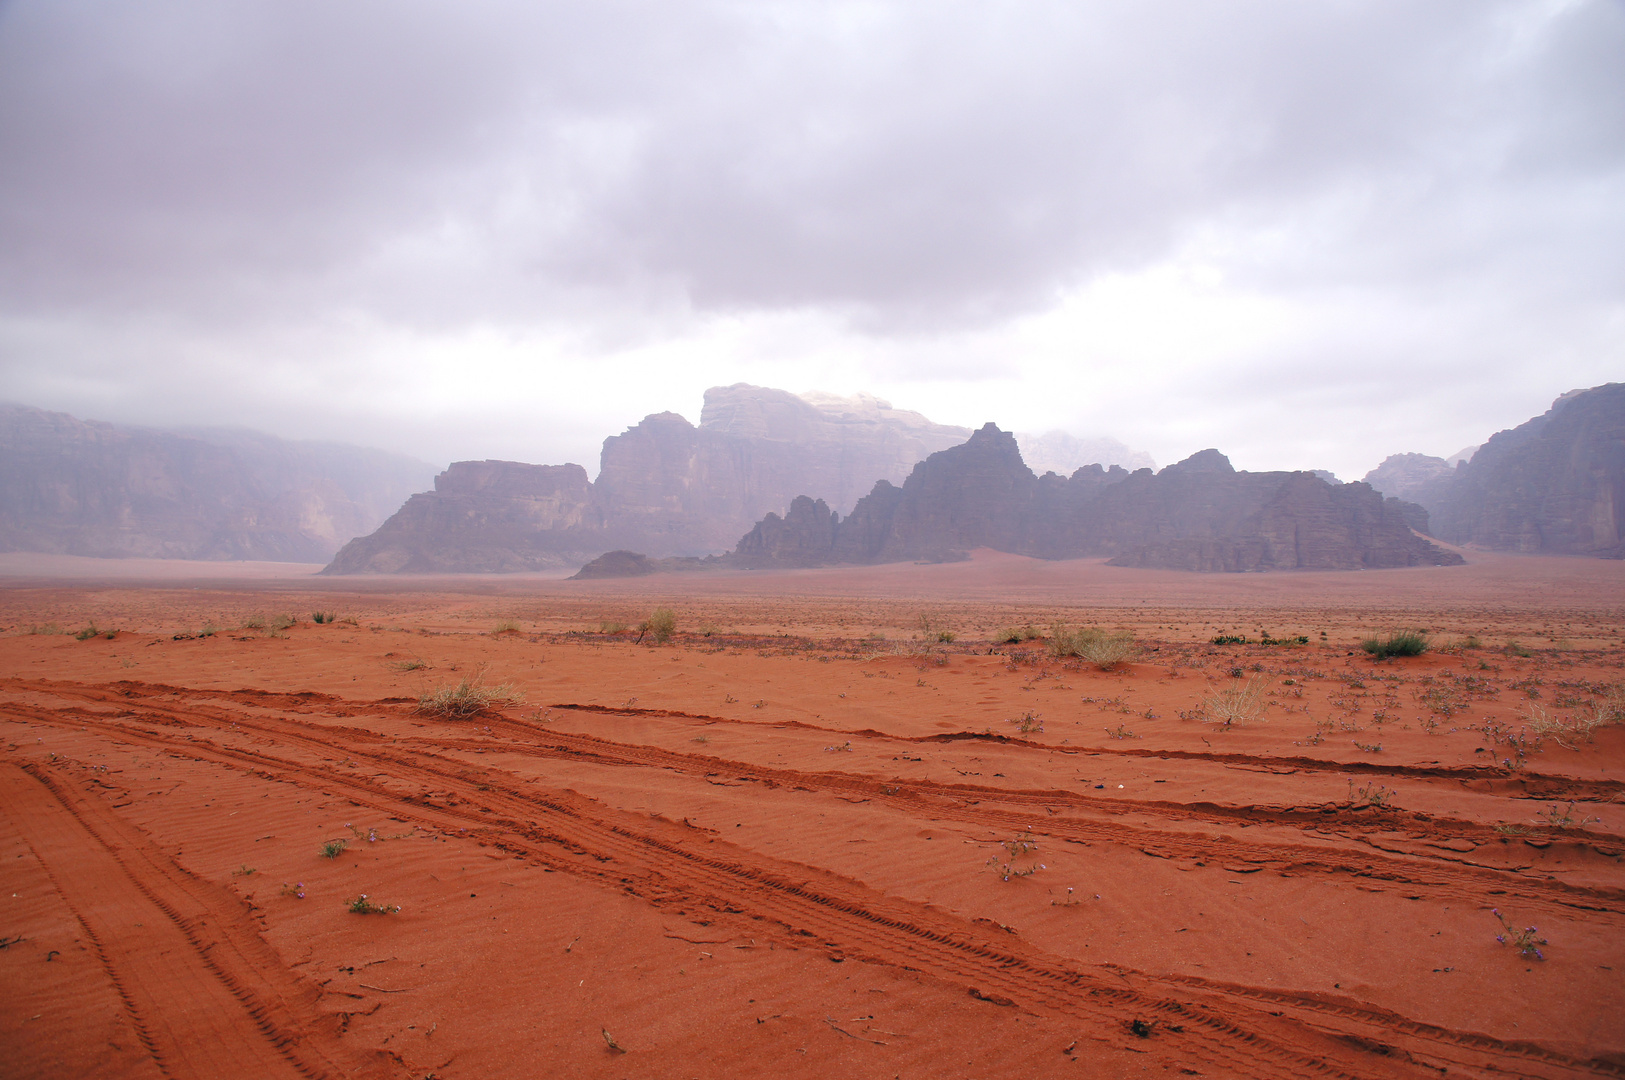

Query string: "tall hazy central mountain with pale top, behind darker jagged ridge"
[325, 383, 970, 573]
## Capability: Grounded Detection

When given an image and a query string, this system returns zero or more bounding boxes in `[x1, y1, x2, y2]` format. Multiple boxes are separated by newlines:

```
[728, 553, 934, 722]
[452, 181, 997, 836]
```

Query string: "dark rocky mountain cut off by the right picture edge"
[1367, 383, 1625, 559]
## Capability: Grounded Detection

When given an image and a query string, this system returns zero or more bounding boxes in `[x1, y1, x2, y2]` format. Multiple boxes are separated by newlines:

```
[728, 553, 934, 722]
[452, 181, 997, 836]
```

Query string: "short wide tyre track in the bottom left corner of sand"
[0, 762, 383, 1080]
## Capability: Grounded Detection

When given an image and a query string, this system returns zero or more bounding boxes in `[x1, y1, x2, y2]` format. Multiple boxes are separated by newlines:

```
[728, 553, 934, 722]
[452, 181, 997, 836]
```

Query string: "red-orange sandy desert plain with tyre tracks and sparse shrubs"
[0, 554, 1625, 1078]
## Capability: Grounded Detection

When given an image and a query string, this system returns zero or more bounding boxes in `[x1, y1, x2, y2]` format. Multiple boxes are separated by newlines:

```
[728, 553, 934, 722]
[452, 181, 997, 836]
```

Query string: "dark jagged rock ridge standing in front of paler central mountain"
[722, 424, 1461, 572]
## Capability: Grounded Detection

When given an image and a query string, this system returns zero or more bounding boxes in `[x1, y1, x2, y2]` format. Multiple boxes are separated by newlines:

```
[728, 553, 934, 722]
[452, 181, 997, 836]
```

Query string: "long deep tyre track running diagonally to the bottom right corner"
[6, 685, 1625, 1077]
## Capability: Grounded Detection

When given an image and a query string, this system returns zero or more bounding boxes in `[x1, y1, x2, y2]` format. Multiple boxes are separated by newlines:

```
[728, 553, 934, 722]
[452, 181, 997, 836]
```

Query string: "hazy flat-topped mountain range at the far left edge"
[0, 404, 434, 562]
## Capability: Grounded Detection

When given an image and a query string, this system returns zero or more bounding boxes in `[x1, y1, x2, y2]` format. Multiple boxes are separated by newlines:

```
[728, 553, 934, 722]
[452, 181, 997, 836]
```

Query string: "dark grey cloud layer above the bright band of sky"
[0, 0, 1625, 328]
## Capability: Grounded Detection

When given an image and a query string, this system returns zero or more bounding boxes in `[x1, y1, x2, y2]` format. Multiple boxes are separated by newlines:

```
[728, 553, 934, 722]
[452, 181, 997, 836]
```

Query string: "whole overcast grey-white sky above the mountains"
[0, 0, 1625, 479]
